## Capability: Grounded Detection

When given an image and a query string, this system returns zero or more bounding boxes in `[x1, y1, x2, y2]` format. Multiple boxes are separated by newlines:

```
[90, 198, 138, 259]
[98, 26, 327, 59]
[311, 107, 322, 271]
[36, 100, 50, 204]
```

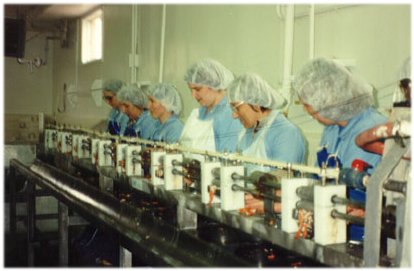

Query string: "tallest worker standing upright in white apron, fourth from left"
[180, 59, 243, 159]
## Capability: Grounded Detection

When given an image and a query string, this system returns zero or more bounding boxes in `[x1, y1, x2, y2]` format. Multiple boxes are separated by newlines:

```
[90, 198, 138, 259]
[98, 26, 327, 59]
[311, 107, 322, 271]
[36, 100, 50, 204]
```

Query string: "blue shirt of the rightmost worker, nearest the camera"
[321, 107, 387, 173]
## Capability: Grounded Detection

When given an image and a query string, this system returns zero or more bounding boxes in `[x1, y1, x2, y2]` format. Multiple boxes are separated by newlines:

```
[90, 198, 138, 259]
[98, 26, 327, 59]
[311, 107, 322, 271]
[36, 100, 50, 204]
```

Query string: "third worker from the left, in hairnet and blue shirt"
[147, 83, 184, 143]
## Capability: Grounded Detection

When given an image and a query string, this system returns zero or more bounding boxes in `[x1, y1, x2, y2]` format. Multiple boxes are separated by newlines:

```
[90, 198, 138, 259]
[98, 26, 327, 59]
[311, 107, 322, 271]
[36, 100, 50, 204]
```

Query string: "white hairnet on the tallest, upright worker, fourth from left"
[184, 59, 234, 90]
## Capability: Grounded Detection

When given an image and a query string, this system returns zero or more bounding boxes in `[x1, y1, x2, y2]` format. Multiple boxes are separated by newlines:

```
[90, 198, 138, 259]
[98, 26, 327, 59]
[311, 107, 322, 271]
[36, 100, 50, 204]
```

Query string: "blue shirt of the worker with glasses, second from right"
[238, 111, 305, 164]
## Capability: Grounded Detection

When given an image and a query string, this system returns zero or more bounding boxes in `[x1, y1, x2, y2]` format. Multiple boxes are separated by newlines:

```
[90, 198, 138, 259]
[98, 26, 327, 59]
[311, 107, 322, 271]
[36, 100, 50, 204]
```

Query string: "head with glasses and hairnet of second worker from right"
[227, 73, 285, 128]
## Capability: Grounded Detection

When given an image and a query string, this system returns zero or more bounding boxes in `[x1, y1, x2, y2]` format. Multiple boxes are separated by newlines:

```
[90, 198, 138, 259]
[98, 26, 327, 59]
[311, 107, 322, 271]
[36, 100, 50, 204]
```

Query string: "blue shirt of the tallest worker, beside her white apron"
[199, 96, 243, 152]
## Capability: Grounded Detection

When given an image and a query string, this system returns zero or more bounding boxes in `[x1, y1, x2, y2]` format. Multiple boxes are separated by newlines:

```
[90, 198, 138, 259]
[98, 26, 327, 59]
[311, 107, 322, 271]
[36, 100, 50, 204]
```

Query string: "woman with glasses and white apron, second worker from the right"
[227, 73, 305, 172]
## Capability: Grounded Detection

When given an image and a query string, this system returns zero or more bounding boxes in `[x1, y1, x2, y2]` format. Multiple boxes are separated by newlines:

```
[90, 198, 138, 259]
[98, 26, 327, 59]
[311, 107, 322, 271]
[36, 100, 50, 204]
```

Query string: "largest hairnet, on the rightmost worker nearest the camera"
[293, 58, 373, 121]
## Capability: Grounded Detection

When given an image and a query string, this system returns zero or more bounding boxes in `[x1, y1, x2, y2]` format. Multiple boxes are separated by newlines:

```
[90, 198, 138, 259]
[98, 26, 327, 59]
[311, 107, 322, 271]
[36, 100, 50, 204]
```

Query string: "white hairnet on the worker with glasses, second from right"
[227, 73, 286, 109]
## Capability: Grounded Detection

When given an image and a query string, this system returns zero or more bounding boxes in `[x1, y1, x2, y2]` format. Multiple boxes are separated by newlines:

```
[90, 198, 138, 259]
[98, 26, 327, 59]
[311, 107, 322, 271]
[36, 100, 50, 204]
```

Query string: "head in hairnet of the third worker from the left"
[147, 83, 181, 119]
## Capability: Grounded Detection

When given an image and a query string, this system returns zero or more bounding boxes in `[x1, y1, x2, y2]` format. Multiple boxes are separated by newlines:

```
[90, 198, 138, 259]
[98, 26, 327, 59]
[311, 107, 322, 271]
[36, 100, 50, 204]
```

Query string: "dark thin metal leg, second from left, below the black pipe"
[26, 180, 36, 267]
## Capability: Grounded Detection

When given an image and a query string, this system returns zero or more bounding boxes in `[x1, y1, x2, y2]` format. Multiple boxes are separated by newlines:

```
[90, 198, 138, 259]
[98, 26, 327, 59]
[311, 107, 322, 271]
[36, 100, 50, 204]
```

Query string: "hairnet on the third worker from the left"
[147, 83, 181, 115]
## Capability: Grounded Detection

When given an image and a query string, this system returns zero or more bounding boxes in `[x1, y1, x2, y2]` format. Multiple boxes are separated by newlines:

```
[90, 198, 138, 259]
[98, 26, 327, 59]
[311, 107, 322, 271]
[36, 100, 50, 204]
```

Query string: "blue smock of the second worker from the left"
[124, 110, 159, 140]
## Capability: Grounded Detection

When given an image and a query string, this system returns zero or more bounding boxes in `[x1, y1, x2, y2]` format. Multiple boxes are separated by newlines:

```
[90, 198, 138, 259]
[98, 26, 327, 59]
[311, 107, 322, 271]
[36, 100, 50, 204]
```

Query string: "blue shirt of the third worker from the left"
[152, 115, 184, 144]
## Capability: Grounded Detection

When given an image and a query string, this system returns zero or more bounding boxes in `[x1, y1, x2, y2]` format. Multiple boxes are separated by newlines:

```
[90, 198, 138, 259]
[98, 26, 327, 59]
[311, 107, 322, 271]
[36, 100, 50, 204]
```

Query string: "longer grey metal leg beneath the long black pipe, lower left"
[58, 201, 69, 266]
